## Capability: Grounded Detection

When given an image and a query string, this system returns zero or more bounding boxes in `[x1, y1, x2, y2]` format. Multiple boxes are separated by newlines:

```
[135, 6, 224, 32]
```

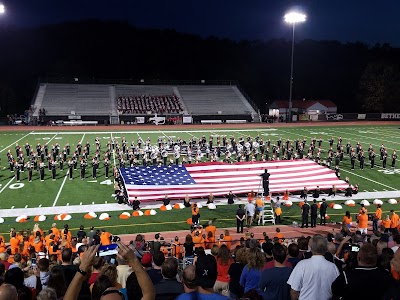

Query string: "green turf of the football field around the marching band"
[0, 125, 400, 237]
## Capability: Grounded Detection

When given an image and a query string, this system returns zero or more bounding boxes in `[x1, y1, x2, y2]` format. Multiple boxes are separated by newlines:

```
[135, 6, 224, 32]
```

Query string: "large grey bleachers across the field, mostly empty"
[33, 83, 257, 123]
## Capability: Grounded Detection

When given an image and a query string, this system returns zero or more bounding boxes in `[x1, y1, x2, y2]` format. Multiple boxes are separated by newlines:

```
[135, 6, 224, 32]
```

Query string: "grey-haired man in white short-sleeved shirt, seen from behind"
[287, 234, 339, 300]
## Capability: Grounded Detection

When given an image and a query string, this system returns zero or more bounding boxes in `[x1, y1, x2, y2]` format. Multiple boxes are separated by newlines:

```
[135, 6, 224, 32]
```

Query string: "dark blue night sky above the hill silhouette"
[0, 0, 400, 47]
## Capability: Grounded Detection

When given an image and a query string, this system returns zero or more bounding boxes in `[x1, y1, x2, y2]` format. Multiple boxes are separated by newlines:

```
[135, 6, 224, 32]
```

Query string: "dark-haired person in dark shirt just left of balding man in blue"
[154, 257, 185, 300]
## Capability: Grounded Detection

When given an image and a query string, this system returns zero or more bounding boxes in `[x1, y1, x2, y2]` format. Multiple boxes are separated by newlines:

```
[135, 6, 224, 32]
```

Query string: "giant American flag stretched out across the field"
[119, 159, 348, 201]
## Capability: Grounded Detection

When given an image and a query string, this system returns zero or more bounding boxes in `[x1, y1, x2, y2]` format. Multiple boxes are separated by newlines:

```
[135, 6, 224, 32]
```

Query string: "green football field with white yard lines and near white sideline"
[0, 124, 400, 234]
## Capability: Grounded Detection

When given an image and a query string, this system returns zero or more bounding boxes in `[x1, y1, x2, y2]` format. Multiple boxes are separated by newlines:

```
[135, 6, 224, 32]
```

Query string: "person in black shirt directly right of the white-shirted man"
[332, 243, 393, 300]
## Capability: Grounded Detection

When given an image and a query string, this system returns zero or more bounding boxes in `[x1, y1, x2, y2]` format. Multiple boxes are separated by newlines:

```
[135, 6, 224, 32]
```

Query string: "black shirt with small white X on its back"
[196, 254, 218, 288]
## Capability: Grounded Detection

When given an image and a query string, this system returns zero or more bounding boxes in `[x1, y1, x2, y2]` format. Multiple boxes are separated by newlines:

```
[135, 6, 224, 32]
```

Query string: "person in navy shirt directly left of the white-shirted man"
[259, 244, 292, 300]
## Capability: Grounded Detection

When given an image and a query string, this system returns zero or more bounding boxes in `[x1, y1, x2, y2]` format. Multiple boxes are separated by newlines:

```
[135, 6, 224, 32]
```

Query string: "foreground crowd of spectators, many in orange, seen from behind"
[0, 218, 400, 300]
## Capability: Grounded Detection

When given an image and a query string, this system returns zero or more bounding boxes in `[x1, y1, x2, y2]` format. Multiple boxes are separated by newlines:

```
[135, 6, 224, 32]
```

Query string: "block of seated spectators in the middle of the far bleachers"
[117, 94, 183, 114]
